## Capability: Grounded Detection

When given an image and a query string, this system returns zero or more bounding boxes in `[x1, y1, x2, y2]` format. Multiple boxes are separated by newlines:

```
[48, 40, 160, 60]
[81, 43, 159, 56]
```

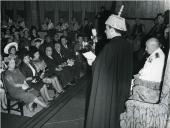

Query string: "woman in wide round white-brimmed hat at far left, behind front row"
[4, 42, 21, 67]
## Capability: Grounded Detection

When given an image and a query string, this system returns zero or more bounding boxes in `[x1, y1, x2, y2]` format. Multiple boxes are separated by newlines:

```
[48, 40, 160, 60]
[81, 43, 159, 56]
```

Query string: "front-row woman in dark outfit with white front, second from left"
[19, 52, 52, 101]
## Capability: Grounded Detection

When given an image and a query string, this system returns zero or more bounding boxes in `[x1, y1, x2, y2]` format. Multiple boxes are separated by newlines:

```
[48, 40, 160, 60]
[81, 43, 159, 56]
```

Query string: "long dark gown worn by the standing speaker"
[85, 36, 132, 128]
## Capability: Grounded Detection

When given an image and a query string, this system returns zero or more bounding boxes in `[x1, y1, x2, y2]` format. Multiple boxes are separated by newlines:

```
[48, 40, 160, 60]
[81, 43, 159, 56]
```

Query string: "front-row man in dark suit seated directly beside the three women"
[44, 46, 73, 86]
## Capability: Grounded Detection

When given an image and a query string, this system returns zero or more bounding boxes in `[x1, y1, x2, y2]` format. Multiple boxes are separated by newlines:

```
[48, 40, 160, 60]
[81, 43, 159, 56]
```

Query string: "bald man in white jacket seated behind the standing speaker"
[130, 38, 165, 103]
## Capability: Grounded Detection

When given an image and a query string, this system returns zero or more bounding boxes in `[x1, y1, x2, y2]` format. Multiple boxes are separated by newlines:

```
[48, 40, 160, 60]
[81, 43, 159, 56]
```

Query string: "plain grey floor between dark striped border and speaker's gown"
[42, 84, 86, 128]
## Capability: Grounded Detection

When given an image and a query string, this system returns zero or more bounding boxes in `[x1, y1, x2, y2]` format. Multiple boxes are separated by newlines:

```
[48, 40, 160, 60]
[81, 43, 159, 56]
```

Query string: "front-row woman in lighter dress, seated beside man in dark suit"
[30, 47, 64, 95]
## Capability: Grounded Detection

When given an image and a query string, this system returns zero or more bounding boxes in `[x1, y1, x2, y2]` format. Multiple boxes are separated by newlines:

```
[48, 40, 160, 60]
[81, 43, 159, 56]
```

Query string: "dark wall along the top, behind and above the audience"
[1, 0, 170, 31]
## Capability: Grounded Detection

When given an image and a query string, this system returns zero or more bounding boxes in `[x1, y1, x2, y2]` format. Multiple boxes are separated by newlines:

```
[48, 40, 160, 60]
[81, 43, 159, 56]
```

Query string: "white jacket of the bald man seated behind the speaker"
[139, 48, 165, 82]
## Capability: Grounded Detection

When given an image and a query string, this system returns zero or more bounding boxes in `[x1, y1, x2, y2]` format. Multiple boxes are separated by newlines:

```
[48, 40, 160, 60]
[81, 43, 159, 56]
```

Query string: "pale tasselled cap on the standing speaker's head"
[105, 6, 127, 31]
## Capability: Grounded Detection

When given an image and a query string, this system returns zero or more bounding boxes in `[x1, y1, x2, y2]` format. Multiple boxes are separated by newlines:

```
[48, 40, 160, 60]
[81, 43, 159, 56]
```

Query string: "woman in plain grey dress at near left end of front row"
[4, 58, 47, 111]
